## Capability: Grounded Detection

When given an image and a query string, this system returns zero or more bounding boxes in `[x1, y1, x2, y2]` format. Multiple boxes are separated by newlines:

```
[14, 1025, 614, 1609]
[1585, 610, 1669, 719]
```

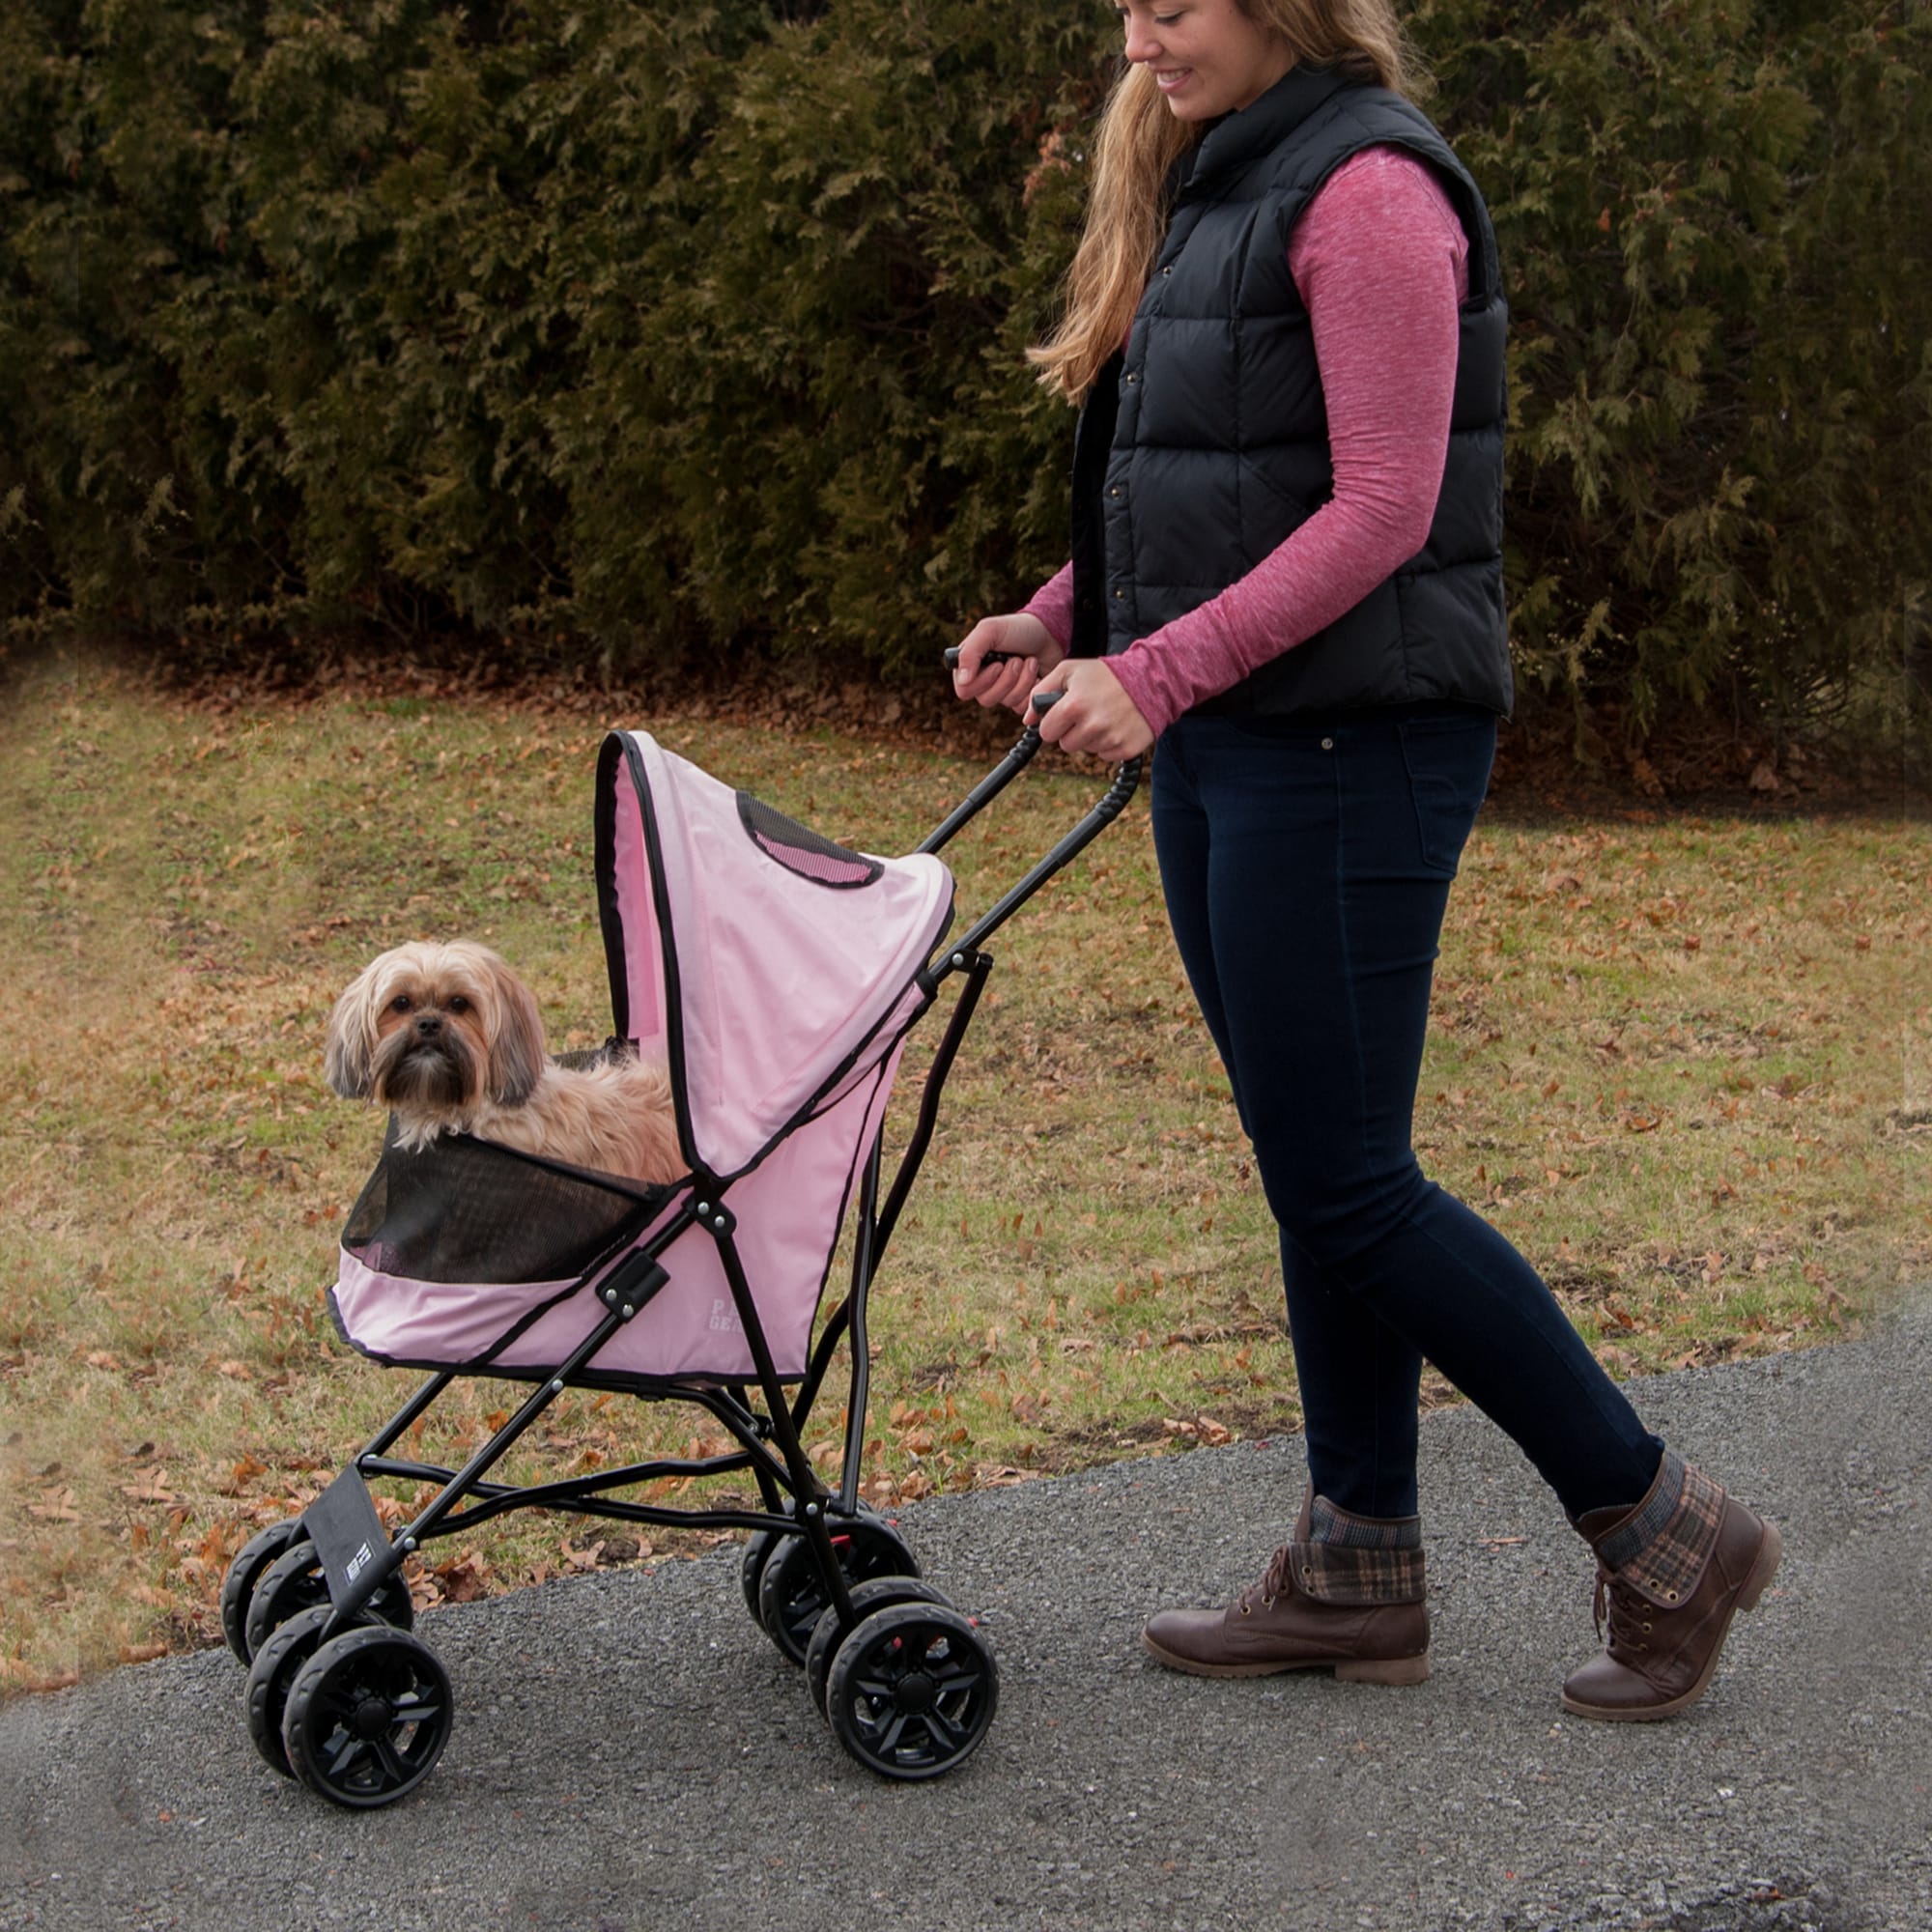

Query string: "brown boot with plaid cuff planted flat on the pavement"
[1140, 1495, 1430, 1685]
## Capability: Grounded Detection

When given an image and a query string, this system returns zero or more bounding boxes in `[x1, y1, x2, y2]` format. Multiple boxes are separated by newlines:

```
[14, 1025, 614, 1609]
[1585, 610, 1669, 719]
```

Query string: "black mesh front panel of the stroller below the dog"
[342, 1134, 670, 1285]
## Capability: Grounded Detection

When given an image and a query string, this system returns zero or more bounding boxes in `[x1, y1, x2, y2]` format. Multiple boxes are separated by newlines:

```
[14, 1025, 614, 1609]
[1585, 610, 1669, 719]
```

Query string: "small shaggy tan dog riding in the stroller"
[323, 941, 686, 1182]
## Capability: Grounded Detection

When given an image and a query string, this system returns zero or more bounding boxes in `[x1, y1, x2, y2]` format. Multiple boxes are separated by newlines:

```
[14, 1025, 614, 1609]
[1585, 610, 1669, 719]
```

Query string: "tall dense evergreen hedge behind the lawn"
[0, 0, 1932, 730]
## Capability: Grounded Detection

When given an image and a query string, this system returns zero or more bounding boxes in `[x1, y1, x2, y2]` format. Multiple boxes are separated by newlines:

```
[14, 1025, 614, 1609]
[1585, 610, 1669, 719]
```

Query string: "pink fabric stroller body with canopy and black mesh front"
[330, 732, 952, 1383]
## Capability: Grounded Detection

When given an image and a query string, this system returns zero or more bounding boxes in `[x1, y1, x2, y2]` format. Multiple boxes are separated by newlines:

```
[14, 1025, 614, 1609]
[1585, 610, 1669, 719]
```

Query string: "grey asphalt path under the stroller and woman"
[0, 1298, 1932, 1932]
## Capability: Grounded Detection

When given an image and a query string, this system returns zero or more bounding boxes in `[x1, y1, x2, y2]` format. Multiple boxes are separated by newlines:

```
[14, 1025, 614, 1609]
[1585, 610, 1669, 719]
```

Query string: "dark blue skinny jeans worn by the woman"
[1153, 705, 1663, 1517]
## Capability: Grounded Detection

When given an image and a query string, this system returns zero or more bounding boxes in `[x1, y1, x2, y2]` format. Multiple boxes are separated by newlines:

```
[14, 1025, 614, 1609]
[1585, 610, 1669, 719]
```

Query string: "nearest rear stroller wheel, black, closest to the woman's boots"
[825, 1604, 999, 1781]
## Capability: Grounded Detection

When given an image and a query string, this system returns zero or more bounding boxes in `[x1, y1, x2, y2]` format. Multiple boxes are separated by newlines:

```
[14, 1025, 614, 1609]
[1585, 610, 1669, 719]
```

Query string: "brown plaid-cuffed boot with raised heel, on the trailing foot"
[1563, 1451, 1783, 1723]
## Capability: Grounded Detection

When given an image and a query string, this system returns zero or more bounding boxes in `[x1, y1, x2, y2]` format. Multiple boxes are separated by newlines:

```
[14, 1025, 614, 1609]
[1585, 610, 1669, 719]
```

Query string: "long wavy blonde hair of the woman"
[1026, 0, 1414, 402]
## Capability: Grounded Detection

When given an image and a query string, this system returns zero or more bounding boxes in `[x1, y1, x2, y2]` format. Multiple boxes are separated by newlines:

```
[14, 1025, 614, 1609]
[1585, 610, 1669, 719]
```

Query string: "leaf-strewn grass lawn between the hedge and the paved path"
[0, 659, 1932, 1689]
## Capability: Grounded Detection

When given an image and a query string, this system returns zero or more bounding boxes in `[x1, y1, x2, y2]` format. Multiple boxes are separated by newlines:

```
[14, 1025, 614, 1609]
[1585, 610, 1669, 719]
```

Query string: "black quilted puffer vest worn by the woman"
[1072, 68, 1513, 713]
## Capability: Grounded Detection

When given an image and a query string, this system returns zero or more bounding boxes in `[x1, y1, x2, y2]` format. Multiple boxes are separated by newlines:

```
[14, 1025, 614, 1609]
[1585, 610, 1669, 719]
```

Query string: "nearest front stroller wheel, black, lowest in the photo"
[282, 1625, 454, 1810]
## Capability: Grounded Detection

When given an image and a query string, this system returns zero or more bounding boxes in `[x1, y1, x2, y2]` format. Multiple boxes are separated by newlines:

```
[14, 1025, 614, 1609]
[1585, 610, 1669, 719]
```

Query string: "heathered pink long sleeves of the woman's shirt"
[1026, 147, 1468, 732]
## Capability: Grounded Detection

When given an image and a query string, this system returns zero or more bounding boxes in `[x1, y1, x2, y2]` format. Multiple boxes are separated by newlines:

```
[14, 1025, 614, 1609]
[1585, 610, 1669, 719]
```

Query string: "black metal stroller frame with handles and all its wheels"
[222, 707, 1142, 1808]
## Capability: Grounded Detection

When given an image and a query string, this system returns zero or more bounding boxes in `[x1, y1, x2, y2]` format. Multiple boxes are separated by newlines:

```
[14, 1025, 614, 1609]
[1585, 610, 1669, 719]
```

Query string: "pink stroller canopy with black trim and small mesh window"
[597, 732, 952, 1180]
